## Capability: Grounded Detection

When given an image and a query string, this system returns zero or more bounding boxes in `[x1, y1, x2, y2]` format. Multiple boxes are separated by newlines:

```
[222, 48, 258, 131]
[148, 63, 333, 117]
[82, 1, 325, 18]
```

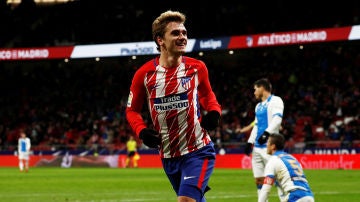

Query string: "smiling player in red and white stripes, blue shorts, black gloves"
[126, 10, 221, 202]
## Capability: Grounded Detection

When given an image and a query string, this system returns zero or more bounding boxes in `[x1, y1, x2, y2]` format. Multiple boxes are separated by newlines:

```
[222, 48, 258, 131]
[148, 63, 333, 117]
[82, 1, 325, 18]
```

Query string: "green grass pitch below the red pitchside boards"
[0, 168, 360, 202]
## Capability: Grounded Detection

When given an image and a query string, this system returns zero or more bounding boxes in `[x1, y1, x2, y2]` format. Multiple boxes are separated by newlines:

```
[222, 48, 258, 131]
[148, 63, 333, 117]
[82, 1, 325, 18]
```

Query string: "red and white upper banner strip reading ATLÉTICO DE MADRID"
[0, 25, 360, 61]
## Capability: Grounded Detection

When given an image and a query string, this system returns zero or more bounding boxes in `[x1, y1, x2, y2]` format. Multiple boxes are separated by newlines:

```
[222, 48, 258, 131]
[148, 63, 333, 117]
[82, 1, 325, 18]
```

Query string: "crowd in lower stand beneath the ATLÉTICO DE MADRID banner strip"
[0, 44, 360, 154]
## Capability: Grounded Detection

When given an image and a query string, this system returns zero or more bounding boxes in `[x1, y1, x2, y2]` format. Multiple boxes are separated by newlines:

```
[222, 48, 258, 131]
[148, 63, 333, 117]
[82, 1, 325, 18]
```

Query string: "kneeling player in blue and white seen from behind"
[258, 134, 314, 202]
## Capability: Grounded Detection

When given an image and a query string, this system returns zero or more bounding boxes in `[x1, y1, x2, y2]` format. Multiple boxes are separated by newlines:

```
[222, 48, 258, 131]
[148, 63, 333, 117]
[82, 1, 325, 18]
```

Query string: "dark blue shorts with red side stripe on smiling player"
[162, 143, 216, 202]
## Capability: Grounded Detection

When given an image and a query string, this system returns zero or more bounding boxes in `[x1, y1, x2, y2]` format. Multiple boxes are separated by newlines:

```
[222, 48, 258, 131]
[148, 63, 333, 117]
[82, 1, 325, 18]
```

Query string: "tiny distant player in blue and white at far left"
[18, 131, 31, 172]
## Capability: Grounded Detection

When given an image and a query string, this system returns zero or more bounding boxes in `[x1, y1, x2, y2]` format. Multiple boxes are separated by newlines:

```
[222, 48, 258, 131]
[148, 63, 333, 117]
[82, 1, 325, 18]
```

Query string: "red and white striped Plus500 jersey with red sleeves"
[126, 56, 221, 158]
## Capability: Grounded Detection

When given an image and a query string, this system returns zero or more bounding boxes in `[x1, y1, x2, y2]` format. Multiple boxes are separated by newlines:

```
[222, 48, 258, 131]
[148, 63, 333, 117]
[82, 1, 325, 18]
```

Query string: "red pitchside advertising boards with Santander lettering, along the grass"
[0, 154, 360, 170]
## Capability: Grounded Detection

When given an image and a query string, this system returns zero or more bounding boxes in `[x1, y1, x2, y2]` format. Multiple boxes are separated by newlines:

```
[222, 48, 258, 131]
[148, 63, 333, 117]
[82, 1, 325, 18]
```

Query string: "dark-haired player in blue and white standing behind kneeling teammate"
[245, 78, 284, 199]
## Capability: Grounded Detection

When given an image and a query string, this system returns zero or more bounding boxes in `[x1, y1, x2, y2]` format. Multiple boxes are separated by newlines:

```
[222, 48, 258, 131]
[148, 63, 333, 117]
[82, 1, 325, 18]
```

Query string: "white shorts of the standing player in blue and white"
[251, 147, 271, 178]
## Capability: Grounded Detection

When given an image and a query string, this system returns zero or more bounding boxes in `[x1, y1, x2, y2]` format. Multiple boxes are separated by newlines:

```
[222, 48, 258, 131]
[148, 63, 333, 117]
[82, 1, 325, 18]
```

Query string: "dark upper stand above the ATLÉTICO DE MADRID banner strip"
[0, 0, 360, 48]
